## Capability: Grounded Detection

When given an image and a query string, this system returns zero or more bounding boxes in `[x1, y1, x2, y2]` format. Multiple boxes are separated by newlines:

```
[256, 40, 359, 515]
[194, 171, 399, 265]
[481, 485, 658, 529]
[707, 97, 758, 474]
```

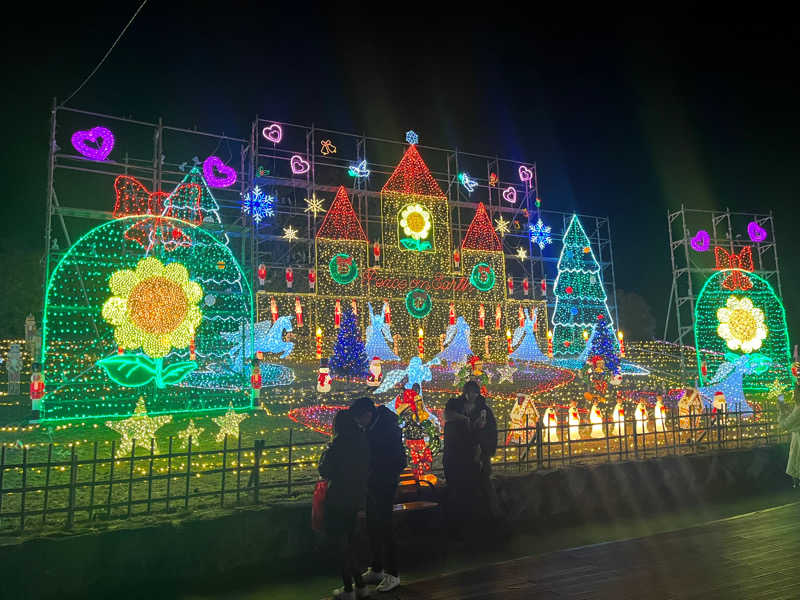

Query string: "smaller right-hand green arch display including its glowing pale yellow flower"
[694, 269, 793, 396]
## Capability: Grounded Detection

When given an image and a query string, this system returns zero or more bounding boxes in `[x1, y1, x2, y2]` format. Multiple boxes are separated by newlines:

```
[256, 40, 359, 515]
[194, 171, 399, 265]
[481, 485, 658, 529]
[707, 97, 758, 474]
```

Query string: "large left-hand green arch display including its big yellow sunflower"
[41, 216, 252, 420]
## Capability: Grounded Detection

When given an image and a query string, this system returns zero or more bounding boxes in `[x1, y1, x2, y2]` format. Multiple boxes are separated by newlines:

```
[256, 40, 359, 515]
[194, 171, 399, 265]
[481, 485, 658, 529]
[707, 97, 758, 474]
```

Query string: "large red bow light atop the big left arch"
[114, 175, 203, 252]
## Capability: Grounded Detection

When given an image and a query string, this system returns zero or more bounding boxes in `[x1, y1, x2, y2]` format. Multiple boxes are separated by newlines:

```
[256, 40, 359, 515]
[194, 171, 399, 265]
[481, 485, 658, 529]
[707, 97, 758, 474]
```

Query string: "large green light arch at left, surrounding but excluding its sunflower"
[41, 216, 254, 421]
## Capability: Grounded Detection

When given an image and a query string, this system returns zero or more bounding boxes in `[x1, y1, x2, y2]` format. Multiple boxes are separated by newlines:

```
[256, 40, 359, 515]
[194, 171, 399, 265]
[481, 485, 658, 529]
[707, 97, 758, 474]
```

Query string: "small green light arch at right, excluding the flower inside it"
[694, 269, 792, 392]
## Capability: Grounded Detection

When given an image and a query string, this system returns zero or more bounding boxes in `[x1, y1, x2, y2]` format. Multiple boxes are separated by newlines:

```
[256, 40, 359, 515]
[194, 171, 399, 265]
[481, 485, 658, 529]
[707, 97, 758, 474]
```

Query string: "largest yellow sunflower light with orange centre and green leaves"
[98, 257, 203, 387]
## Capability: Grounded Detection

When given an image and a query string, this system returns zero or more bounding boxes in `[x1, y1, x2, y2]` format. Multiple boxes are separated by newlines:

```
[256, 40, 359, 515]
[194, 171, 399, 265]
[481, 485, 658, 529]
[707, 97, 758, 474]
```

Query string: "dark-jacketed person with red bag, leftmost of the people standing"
[319, 409, 369, 600]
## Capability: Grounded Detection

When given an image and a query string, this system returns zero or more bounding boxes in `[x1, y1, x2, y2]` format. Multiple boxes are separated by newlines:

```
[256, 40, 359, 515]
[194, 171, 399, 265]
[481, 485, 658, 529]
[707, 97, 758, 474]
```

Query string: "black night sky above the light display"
[1, 8, 800, 332]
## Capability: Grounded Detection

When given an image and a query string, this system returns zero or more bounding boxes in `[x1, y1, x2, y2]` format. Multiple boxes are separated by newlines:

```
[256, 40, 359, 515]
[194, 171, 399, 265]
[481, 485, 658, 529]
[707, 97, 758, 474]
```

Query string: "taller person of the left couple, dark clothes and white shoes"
[350, 398, 407, 592]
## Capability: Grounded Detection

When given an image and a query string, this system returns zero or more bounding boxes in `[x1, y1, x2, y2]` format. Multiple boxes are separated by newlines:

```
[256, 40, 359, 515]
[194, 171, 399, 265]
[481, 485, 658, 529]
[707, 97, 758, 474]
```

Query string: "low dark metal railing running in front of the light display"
[0, 409, 787, 532]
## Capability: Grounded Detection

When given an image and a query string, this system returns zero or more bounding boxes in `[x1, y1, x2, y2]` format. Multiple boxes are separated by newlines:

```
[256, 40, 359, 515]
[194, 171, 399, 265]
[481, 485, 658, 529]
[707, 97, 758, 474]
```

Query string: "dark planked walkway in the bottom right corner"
[392, 503, 800, 600]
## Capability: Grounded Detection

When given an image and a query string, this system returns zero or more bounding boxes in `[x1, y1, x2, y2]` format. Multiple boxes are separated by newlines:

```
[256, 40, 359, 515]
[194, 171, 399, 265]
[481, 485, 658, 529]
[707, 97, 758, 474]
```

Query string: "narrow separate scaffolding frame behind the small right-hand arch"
[664, 205, 783, 356]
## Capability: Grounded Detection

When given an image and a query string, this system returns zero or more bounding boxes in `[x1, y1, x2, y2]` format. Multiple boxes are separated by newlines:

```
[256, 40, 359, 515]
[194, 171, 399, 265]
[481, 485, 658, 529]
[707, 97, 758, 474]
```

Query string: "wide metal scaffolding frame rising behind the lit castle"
[44, 99, 617, 350]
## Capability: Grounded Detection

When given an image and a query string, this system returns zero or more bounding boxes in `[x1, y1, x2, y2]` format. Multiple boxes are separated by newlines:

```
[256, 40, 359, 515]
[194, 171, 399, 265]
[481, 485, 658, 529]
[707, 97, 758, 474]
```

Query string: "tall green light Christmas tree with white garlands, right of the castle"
[553, 215, 613, 356]
